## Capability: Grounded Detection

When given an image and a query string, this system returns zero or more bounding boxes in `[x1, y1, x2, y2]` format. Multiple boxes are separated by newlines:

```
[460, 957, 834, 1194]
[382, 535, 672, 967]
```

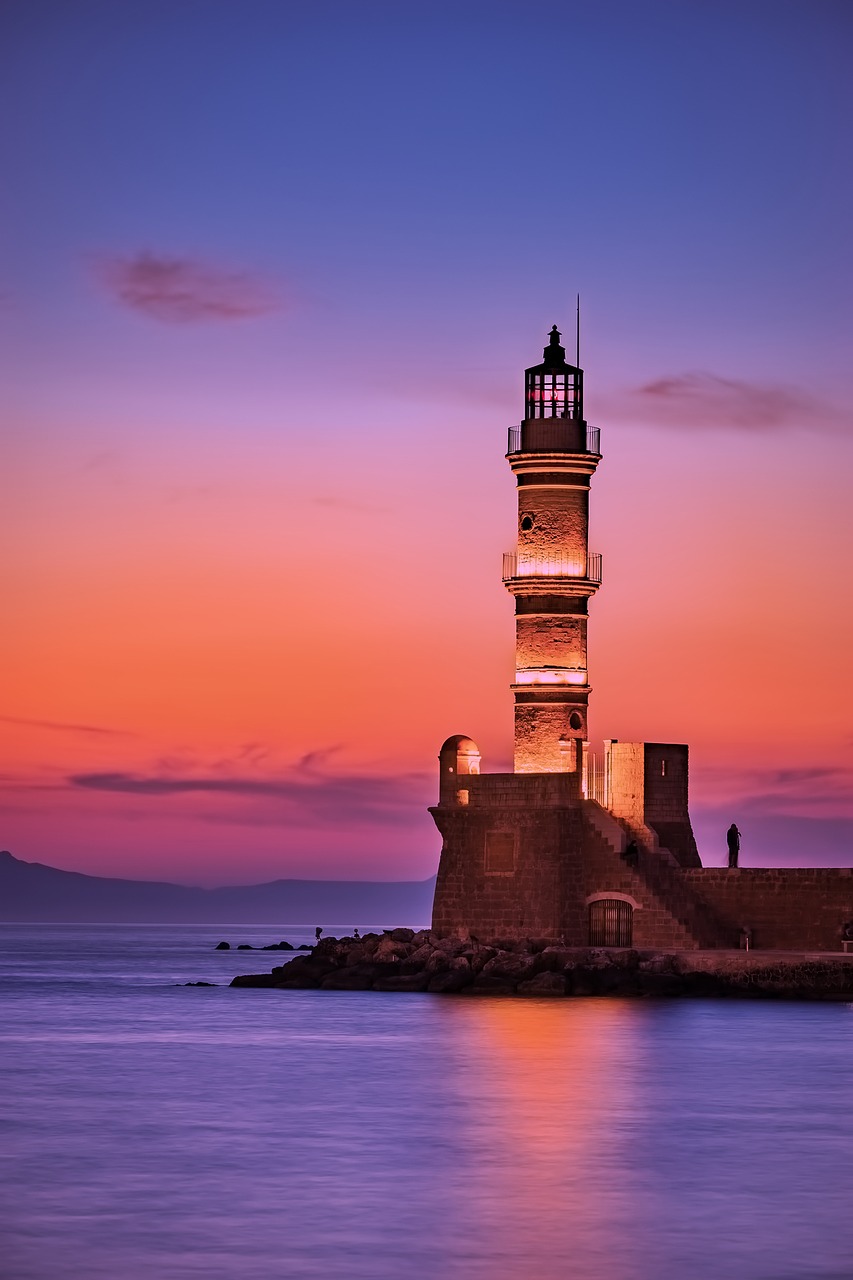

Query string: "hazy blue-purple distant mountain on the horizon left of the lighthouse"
[0, 852, 435, 928]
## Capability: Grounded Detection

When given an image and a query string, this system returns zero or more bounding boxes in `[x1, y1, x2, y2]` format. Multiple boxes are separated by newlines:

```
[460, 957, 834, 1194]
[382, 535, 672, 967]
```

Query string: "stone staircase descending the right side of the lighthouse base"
[583, 800, 738, 950]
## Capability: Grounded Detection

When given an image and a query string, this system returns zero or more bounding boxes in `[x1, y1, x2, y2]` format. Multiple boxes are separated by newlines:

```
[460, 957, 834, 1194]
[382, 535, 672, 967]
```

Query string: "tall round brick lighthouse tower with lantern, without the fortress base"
[503, 325, 601, 783]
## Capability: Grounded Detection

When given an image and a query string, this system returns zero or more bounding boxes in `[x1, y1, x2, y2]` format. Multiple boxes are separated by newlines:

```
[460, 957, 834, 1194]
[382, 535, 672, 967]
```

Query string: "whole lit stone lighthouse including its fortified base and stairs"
[429, 325, 701, 948]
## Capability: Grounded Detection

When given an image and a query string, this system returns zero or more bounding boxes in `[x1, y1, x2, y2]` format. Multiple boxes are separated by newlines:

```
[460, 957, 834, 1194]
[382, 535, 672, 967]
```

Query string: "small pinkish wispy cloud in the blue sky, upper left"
[92, 251, 282, 324]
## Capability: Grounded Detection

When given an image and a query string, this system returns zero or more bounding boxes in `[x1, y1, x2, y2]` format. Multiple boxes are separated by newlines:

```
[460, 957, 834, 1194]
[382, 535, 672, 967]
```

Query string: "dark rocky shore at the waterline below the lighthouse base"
[231, 929, 853, 1001]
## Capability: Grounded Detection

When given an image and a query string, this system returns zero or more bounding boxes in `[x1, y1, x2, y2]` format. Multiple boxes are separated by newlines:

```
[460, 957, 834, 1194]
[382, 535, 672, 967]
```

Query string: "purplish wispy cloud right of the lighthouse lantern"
[613, 372, 844, 431]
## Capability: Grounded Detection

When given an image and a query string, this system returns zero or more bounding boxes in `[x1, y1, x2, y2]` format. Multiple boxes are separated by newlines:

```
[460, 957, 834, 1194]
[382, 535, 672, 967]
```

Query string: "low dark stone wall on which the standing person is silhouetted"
[681, 867, 853, 951]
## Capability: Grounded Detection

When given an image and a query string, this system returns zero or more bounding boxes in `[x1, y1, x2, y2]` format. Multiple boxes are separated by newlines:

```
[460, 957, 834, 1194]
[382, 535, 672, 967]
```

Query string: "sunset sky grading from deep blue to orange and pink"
[0, 0, 853, 884]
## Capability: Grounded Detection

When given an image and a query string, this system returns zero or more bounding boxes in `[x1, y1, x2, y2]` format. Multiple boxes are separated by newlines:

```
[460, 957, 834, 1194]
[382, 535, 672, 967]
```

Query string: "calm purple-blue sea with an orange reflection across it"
[0, 925, 853, 1280]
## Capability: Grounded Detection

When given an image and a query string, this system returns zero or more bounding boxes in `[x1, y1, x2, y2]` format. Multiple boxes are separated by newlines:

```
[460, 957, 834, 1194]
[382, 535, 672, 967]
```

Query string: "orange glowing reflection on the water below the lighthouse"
[435, 997, 644, 1280]
